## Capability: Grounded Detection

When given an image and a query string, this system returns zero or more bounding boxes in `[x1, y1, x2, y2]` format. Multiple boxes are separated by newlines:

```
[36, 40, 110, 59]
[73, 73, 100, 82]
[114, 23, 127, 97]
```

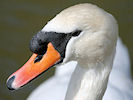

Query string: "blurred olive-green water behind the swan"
[0, 0, 133, 100]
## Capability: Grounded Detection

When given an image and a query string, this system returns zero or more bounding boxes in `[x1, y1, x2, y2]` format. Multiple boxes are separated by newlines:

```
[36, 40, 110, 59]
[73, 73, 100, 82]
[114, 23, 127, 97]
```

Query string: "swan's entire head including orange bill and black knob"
[7, 3, 118, 89]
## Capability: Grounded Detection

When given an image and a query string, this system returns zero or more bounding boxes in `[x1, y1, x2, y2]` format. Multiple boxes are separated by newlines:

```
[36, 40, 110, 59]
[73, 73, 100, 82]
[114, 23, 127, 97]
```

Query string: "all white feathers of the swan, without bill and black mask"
[28, 4, 133, 100]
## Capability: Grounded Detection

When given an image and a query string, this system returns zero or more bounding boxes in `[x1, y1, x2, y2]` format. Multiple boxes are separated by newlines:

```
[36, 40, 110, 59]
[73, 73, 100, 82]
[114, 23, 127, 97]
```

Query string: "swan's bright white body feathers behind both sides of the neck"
[28, 39, 133, 100]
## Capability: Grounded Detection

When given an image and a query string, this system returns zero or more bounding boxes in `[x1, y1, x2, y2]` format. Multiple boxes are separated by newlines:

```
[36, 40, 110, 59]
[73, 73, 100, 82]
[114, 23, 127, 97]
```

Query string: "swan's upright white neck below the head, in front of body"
[65, 63, 111, 100]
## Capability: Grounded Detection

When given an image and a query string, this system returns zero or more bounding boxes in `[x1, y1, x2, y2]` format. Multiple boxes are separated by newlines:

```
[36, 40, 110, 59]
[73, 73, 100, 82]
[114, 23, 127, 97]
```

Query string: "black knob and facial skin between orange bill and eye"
[30, 30, 81, 62]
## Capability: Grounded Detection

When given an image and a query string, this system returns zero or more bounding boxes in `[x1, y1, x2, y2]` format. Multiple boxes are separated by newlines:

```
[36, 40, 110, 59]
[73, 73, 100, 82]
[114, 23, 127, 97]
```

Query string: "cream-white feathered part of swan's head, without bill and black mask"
[42, 3, 118, 63]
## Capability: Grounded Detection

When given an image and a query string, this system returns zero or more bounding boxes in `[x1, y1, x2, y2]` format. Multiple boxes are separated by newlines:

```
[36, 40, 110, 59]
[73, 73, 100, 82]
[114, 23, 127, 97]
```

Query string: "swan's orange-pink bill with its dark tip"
[7, 43, 61, 90]
